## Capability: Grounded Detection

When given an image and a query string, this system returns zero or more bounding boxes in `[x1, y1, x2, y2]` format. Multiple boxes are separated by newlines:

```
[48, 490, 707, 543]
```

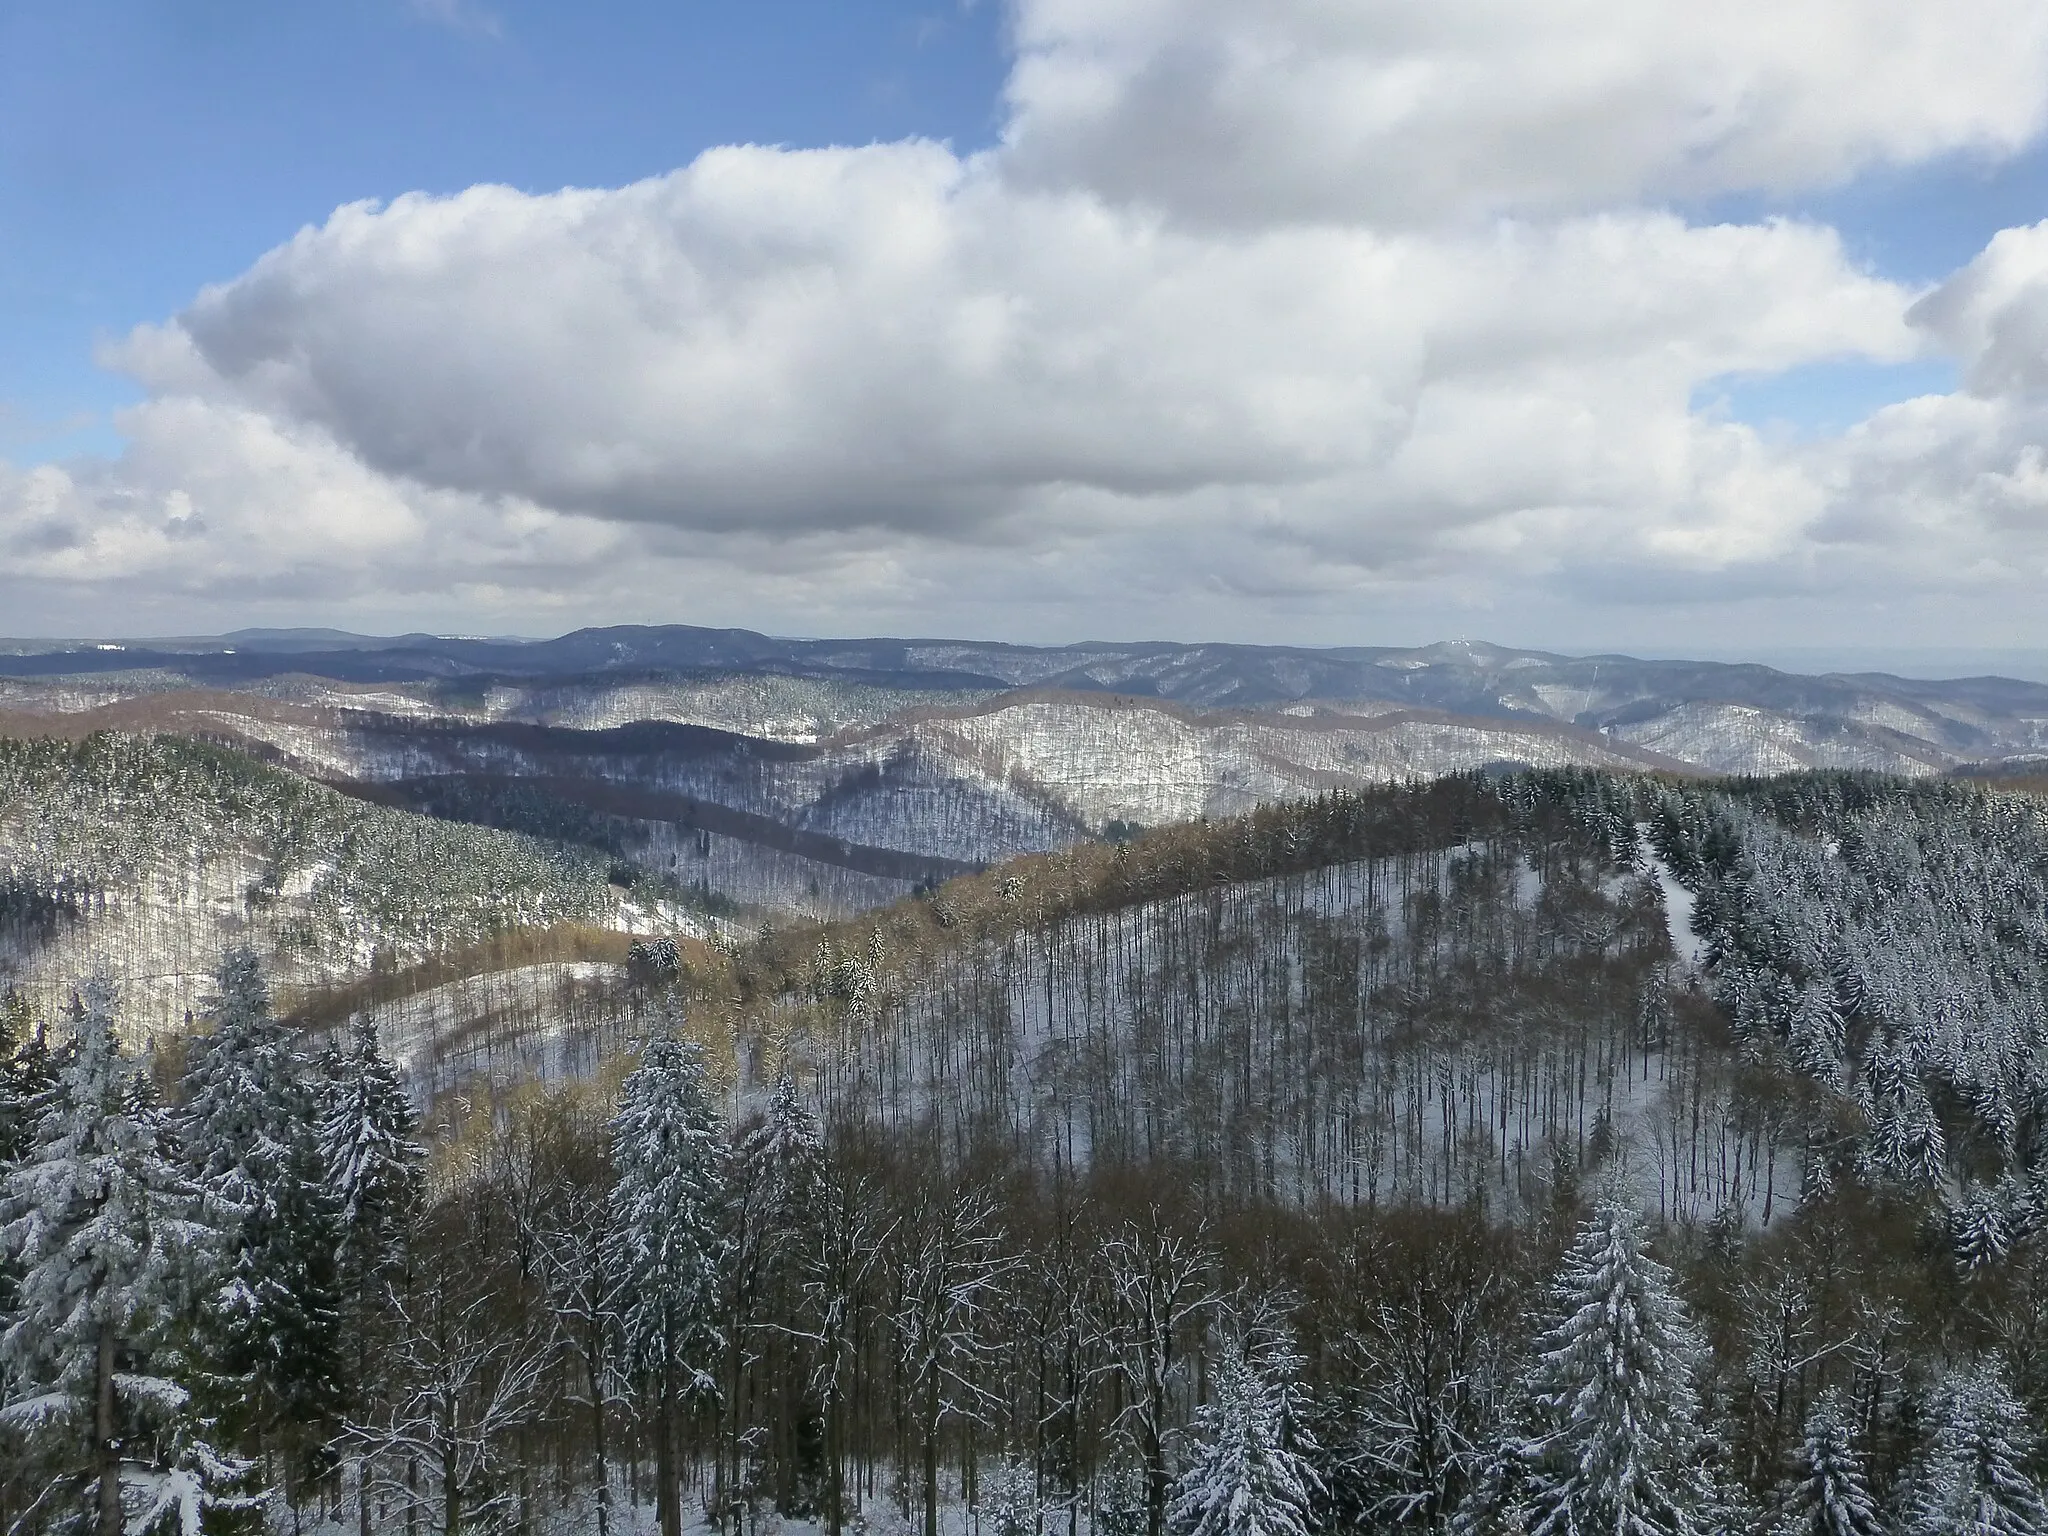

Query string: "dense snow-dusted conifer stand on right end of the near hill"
[1657, 774, 2048, 1262]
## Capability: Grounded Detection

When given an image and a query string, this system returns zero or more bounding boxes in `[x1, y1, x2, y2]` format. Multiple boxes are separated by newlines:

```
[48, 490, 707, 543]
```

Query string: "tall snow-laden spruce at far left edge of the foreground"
[0, 975, 246, 1536]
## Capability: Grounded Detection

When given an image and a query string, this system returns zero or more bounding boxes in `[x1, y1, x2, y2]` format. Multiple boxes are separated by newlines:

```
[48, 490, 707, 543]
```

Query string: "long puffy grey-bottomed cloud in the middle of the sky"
[121, 157, 1911, 539]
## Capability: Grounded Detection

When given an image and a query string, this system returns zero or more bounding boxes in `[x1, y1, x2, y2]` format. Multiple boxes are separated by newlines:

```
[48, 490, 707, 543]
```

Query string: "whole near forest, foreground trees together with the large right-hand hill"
[16, 770, 2048, 1536]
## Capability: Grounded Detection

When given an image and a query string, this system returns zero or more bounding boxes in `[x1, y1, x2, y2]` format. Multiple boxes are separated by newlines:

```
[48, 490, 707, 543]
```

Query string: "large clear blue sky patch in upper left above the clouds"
[0, 0, 1006, 459]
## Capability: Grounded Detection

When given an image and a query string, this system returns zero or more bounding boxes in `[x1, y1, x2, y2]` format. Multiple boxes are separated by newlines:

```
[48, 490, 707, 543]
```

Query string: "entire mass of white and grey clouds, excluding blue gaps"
[12, 0, 2048, 639]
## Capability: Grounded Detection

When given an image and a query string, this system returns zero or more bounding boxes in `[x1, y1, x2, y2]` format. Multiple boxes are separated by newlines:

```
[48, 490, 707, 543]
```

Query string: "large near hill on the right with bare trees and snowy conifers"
[707, 772, 2048, 1247]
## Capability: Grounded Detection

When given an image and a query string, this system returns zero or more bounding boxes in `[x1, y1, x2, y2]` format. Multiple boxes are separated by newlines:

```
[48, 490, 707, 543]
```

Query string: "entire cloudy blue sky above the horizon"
[0, 0, 2048, 655]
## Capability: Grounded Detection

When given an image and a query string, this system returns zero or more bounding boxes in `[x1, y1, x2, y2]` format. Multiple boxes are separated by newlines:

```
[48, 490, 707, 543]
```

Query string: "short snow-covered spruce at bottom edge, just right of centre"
[1167, 1337, 1321, 1536]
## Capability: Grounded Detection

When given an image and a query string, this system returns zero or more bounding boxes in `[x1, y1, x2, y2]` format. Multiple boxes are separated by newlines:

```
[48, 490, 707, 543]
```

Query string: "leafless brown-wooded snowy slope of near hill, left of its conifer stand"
[720, 774, 1695, 1214]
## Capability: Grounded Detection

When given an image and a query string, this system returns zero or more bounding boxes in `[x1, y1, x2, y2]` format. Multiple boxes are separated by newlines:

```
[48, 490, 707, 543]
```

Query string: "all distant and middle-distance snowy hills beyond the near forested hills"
[0, 625, 2048, 915]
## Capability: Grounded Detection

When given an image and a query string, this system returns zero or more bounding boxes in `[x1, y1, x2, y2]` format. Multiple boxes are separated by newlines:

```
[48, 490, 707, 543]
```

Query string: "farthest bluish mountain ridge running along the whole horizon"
[0, 625, 2048, 772]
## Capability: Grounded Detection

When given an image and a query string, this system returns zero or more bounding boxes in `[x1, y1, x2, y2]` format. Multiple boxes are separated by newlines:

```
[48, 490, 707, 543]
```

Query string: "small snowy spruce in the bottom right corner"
[1905, 1360, 2048, 1536]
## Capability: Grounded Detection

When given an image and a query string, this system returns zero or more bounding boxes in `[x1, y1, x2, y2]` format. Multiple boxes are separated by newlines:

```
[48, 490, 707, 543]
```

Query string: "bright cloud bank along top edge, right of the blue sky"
[1008, 0, 2048, 225]
